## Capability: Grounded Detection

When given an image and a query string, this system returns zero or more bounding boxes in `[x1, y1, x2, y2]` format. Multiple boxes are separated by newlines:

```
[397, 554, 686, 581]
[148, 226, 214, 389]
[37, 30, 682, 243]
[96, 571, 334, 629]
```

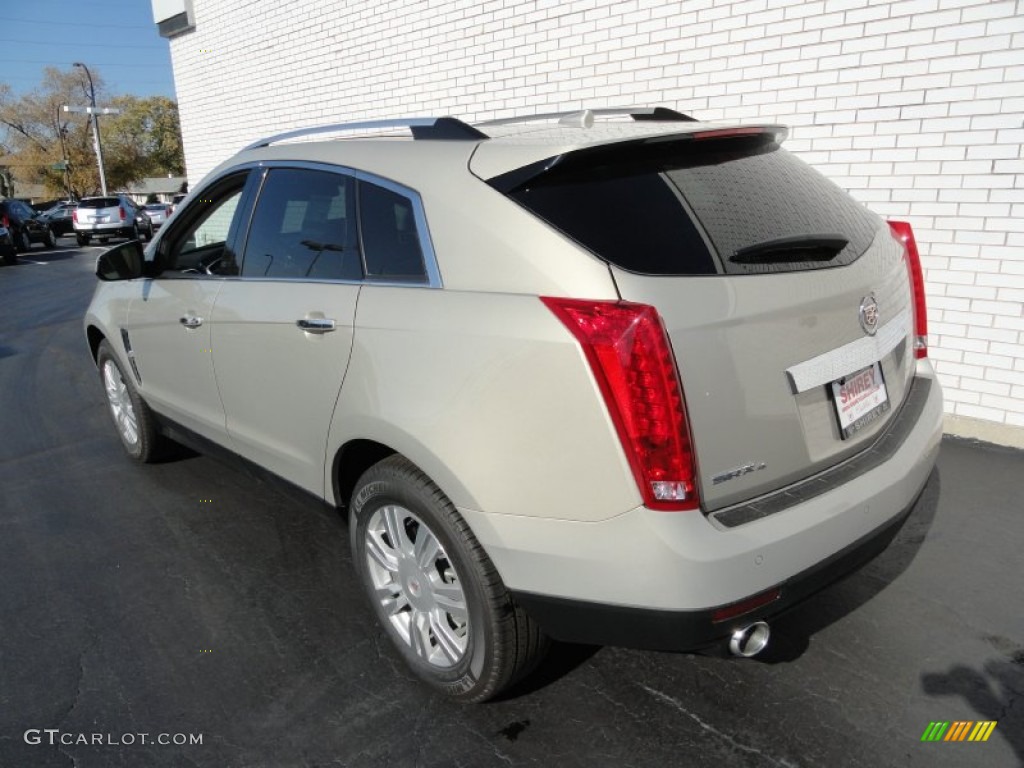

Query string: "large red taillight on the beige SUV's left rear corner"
[541, 297, 700, 510]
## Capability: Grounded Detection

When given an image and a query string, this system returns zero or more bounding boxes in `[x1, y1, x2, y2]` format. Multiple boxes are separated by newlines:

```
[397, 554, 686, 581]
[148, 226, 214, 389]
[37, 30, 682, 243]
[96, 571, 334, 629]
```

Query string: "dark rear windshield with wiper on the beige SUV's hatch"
[503, 137, 881, 275]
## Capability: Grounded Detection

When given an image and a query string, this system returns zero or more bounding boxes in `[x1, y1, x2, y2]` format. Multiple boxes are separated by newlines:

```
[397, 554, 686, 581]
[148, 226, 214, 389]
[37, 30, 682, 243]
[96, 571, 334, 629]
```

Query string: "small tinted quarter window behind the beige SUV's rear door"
[359, 181, 427, 283]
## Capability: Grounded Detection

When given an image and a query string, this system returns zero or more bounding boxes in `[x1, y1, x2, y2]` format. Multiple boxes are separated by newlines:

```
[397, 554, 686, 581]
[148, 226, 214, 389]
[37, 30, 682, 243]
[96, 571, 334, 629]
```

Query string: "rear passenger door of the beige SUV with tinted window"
[212, 166, 362, 495]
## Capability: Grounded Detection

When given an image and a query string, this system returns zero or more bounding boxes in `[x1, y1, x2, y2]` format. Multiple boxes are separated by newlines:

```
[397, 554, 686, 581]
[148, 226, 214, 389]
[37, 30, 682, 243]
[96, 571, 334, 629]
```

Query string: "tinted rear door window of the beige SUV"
[242, 168, 362, 280]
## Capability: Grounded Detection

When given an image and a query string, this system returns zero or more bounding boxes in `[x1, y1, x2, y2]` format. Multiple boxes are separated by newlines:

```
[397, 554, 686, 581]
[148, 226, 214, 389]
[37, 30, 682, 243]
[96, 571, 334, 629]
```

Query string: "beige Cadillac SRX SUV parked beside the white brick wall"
[84, 109, 942, 701]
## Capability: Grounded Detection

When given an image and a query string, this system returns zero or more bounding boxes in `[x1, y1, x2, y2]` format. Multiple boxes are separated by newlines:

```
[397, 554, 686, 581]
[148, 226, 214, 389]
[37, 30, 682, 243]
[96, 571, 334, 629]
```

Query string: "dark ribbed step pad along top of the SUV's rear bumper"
[709, 377, 932, 528]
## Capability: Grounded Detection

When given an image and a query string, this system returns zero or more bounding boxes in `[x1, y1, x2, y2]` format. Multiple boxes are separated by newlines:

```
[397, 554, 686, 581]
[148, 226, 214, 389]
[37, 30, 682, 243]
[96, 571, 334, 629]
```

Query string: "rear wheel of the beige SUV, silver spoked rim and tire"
[349, 455, 548, 702]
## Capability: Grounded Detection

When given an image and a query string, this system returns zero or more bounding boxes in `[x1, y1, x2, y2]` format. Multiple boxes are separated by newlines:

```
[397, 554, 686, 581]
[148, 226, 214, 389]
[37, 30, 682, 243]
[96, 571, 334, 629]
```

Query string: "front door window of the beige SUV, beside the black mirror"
[161, 177, 248, 274]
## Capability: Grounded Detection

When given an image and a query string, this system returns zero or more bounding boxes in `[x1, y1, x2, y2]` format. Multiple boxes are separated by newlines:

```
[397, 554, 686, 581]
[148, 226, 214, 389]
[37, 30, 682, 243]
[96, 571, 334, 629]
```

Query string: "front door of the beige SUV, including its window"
[126, 171, 249, 444]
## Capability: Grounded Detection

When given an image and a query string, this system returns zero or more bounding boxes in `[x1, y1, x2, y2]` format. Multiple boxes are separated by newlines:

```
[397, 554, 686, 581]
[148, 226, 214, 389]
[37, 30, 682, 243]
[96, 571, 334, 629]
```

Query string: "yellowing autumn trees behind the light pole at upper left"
[0, 68, 184, 197]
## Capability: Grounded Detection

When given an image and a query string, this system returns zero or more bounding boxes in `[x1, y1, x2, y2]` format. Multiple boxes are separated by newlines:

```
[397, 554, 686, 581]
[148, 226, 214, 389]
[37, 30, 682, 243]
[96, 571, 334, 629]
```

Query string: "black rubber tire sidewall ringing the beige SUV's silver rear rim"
[349, 468, 495, 698]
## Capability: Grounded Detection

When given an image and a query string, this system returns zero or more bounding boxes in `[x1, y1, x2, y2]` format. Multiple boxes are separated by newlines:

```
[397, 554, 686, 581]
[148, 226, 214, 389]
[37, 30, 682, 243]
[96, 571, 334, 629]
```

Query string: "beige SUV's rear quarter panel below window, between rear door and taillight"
[327, 286, 640, 520]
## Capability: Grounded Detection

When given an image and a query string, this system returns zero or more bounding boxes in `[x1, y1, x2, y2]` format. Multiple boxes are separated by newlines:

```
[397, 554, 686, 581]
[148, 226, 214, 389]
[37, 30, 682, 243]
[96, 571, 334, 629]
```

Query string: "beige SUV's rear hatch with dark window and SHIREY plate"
[490, 128, 914, 512]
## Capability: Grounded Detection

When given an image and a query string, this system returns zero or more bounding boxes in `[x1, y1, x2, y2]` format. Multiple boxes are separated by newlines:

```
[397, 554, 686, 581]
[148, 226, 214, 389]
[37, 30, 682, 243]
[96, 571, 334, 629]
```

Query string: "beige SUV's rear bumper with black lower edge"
[462, 361, 942, 649]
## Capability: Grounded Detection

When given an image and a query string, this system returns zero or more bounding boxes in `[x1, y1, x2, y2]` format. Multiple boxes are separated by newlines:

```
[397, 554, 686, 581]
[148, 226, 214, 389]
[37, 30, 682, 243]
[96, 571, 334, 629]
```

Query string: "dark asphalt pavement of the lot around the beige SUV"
[0, 239, 1024, 768]
